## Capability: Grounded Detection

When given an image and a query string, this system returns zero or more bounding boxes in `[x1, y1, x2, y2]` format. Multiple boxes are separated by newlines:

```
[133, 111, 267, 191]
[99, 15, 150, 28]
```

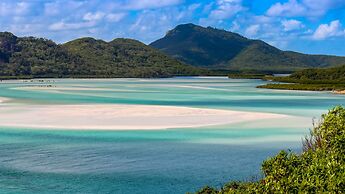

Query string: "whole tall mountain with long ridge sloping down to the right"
[150, 24, 345, 72]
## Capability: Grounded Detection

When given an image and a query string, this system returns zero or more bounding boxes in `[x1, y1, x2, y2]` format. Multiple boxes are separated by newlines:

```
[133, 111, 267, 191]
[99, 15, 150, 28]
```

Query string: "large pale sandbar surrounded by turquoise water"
[0, 104, 287, 130]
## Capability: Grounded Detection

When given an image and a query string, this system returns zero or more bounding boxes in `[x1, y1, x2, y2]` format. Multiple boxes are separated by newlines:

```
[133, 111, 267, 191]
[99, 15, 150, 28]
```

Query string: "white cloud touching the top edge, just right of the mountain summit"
[210, 0, 246, 20]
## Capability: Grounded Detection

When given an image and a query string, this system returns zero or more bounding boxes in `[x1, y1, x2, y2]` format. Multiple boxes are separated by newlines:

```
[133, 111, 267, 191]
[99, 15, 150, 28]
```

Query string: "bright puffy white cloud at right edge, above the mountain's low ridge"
[312, 20, 345, 40]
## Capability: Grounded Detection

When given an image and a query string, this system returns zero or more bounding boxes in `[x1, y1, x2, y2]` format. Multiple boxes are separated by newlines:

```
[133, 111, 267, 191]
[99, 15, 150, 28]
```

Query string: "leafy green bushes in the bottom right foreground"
[197, 107, 345, 194]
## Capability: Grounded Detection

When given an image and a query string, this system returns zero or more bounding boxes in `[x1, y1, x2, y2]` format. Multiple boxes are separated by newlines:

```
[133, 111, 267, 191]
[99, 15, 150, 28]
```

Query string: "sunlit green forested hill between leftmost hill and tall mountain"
[62, 38, 203, 77]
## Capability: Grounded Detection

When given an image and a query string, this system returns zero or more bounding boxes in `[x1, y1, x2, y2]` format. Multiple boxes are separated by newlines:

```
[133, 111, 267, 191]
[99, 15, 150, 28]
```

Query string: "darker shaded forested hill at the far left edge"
[0, 33, 82, 77]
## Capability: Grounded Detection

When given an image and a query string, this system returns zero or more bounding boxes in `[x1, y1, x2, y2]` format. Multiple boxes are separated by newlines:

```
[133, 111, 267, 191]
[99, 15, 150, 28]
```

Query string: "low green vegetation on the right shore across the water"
[258, 65, 345, 91]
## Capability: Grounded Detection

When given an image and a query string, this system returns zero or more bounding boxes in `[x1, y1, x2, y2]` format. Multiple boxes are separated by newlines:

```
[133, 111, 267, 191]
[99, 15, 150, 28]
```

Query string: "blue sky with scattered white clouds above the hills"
[0, 0, 345, 56]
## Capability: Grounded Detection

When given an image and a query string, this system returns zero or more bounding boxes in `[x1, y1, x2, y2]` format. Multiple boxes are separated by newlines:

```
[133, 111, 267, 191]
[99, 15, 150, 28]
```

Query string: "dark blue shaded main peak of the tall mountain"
[150, 24, 250, 67]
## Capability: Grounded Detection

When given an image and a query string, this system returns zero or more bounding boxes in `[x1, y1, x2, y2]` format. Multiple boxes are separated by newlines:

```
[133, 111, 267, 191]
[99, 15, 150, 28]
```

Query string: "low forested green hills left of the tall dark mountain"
[0, 32, 207, 78]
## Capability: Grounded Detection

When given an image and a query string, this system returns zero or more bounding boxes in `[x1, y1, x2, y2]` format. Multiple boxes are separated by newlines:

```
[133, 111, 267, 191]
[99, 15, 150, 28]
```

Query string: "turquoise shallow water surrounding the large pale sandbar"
[0, 77, 345, 193]
